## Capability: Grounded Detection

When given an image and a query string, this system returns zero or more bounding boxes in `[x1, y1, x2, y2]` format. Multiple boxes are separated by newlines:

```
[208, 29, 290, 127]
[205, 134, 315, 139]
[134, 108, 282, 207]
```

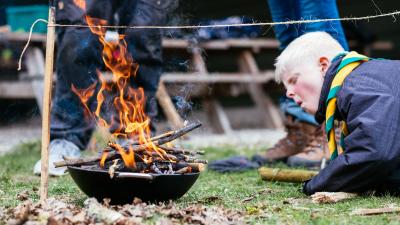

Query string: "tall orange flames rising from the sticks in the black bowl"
[72, 15, 165, 168]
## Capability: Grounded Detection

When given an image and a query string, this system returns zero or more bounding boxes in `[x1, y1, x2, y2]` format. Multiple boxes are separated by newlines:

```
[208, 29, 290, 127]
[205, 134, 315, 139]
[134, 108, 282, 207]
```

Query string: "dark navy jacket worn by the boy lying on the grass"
[303, 55, 400, 194]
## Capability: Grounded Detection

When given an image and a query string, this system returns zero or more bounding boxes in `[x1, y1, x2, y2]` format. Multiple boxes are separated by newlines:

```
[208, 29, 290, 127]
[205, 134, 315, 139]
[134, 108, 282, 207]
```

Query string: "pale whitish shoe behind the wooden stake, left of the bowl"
[33, 139, 81, 176]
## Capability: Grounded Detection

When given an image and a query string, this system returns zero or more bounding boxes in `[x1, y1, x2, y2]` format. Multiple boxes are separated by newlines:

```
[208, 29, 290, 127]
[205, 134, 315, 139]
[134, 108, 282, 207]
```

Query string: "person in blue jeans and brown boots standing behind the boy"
[253, 0, 348, 167]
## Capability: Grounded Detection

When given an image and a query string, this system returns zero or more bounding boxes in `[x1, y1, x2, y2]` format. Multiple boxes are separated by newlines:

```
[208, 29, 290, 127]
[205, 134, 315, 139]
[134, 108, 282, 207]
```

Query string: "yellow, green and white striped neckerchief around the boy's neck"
[325, 52, 369, 160]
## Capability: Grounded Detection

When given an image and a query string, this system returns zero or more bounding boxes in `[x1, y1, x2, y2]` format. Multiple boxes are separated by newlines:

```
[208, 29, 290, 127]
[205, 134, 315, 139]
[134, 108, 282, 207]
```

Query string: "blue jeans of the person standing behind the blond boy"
[268, 0, 349, 125]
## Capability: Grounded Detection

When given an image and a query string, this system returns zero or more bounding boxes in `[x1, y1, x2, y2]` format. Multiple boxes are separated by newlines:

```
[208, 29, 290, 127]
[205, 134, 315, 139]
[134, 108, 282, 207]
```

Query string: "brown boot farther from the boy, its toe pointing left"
[252, 117, 318, 165]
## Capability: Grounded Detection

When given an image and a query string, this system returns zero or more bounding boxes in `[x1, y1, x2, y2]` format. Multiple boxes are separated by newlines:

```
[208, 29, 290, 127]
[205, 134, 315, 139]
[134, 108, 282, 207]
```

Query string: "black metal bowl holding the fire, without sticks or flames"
[68, 166, 200, 204]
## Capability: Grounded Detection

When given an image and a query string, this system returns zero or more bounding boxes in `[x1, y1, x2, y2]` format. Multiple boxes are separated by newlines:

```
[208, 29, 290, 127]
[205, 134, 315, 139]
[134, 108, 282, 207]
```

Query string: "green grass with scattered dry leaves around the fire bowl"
[0, 142, 400, 225]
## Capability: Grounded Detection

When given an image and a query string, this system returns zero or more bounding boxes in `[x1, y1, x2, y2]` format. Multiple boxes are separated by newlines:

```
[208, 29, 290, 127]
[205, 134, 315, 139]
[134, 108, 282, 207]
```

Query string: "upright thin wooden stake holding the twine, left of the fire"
[40, 6, 56, 201]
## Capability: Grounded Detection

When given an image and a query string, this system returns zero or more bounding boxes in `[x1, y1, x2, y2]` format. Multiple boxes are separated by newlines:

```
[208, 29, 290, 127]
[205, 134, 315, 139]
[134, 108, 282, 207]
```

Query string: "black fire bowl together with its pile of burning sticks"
[55, 123, 207, 204]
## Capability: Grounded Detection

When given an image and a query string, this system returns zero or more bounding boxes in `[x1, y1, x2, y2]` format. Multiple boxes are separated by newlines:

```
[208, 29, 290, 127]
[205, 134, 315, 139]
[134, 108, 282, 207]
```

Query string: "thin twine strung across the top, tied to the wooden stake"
[18, 10, 400, 70]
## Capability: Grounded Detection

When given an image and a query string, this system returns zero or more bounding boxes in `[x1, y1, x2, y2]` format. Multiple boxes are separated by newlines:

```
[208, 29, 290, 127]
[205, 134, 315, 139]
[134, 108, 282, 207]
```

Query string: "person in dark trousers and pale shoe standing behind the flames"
[34, 0, 178, 176]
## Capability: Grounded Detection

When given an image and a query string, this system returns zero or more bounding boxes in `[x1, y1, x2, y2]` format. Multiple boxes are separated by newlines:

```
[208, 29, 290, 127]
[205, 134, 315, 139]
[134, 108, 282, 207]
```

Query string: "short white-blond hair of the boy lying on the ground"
[275, 31, 344, 83]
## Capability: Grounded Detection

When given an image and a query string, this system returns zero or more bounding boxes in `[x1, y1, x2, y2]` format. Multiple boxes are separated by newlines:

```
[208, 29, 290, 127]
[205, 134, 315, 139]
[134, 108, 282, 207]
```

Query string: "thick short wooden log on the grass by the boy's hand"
[258, 167, 318, 183]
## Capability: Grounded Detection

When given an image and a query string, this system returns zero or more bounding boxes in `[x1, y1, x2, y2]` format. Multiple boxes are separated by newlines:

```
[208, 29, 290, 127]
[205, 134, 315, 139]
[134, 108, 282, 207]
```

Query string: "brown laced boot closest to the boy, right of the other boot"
[287, 126, 329, 168]
